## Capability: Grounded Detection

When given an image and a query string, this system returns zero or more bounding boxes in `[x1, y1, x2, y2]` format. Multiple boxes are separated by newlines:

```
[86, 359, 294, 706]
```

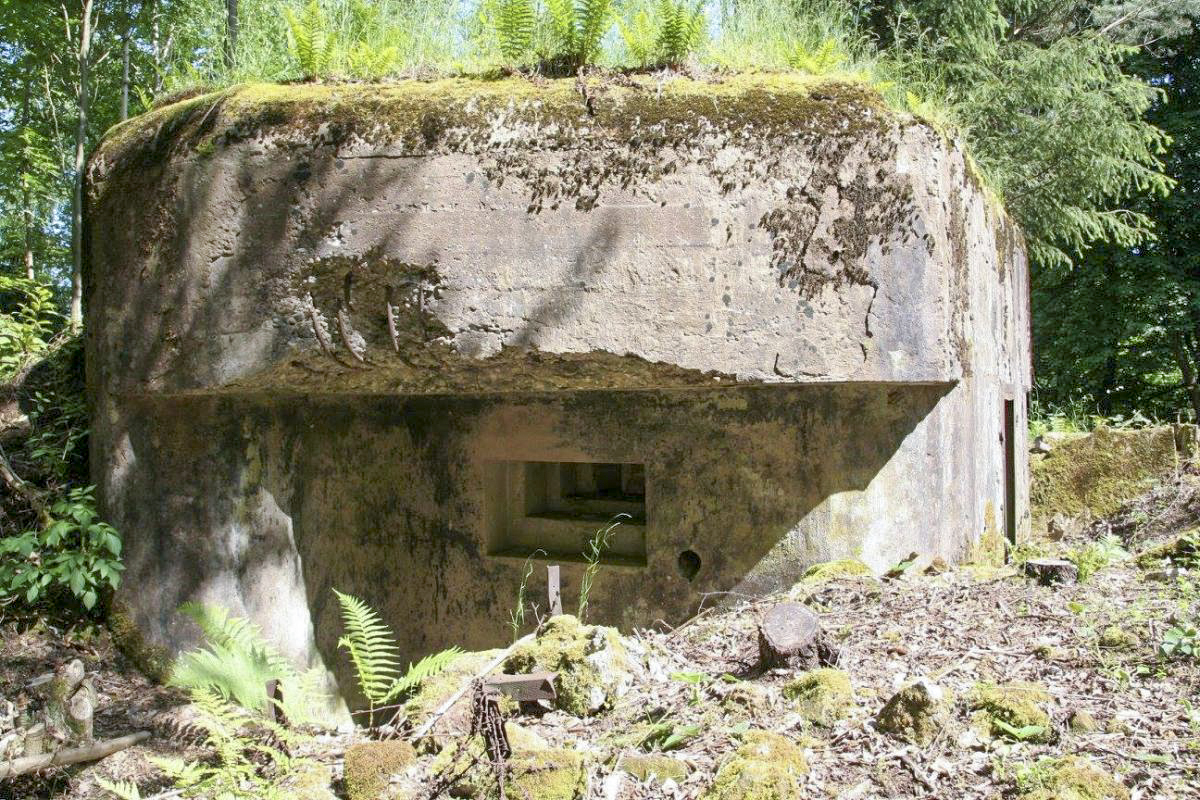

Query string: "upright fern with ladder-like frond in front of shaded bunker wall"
[334, 589, 462, 714]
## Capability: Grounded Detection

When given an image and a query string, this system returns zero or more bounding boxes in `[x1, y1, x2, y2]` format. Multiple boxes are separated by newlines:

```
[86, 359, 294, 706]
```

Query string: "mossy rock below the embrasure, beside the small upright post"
[504, 614, 631, 716]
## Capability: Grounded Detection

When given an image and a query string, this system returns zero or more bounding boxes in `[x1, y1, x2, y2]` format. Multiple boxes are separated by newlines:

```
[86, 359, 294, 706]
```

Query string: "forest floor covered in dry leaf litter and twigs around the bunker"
[0, 471, 1200, 800]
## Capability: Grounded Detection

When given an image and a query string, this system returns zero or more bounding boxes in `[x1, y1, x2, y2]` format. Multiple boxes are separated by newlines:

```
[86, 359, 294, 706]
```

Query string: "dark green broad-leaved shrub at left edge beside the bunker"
[0, 487, 125, 610]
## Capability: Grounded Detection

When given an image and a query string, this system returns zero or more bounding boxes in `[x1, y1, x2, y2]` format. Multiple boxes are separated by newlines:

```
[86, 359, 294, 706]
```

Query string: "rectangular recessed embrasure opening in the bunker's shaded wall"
[485, 461, 647, 566]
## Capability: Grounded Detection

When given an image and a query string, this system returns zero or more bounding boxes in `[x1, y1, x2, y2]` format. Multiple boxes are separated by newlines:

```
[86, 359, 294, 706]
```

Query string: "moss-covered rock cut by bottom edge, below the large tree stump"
[701, 730, 809, 800]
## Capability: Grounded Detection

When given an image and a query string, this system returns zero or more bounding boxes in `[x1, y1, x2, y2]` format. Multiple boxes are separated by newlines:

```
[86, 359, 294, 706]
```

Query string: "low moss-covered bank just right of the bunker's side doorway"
[1030, 427, 1177, 525]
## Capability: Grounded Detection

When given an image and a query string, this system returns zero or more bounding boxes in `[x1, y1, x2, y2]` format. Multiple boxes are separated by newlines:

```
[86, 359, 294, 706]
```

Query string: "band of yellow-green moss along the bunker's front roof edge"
[96, 73, 892, 170]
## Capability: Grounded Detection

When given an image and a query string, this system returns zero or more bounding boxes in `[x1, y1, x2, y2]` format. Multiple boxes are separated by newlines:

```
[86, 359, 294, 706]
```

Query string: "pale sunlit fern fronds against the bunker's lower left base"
[170, 603, 324, 723]
